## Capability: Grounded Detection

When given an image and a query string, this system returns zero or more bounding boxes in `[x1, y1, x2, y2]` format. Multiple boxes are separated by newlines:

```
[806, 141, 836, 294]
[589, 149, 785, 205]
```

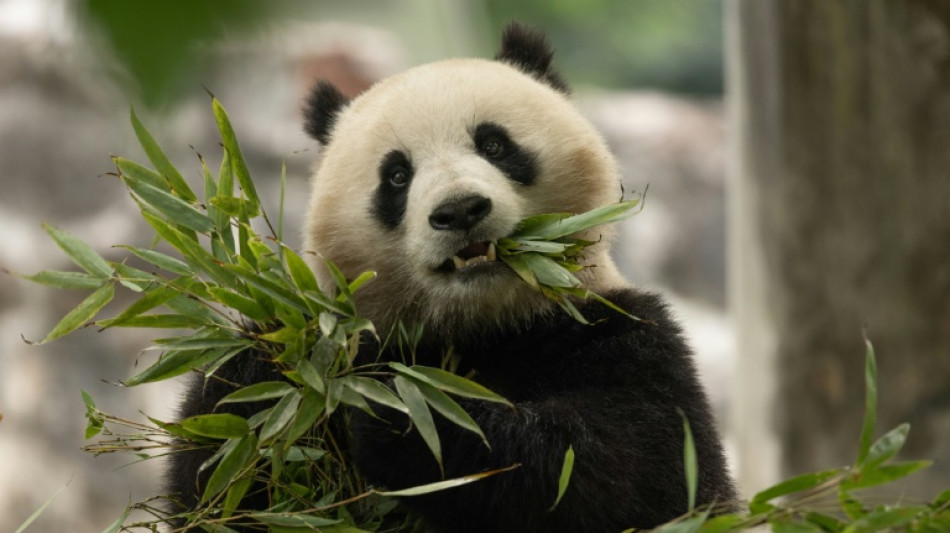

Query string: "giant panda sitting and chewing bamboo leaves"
[170, 24, 736, 533]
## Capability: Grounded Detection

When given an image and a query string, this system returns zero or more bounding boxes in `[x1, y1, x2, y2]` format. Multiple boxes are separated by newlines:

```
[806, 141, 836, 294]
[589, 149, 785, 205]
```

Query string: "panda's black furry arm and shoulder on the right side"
[351, 292, 734, 531]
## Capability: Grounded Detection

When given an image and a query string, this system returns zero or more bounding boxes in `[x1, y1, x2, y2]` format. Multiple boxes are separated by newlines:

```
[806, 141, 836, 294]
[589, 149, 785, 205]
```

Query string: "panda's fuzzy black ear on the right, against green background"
[495, 22, 571, 94]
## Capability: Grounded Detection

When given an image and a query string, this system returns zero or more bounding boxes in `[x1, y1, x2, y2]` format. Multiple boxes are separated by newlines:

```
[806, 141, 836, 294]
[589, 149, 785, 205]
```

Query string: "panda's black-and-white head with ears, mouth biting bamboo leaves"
[305, 24, 622, 334]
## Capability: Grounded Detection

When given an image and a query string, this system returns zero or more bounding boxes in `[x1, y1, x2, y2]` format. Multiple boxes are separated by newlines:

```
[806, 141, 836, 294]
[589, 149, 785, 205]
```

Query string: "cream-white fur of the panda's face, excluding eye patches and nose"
[305, 59, 622, 331]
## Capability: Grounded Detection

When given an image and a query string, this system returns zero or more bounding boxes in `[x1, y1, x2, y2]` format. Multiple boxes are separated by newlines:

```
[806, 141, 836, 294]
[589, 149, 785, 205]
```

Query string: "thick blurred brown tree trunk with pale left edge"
[727, 0, 950, 497]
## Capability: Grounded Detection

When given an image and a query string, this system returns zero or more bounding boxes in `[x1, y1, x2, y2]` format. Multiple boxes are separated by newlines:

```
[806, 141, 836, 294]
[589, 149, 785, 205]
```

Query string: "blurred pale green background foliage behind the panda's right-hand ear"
[486, 0, 723, 95]
